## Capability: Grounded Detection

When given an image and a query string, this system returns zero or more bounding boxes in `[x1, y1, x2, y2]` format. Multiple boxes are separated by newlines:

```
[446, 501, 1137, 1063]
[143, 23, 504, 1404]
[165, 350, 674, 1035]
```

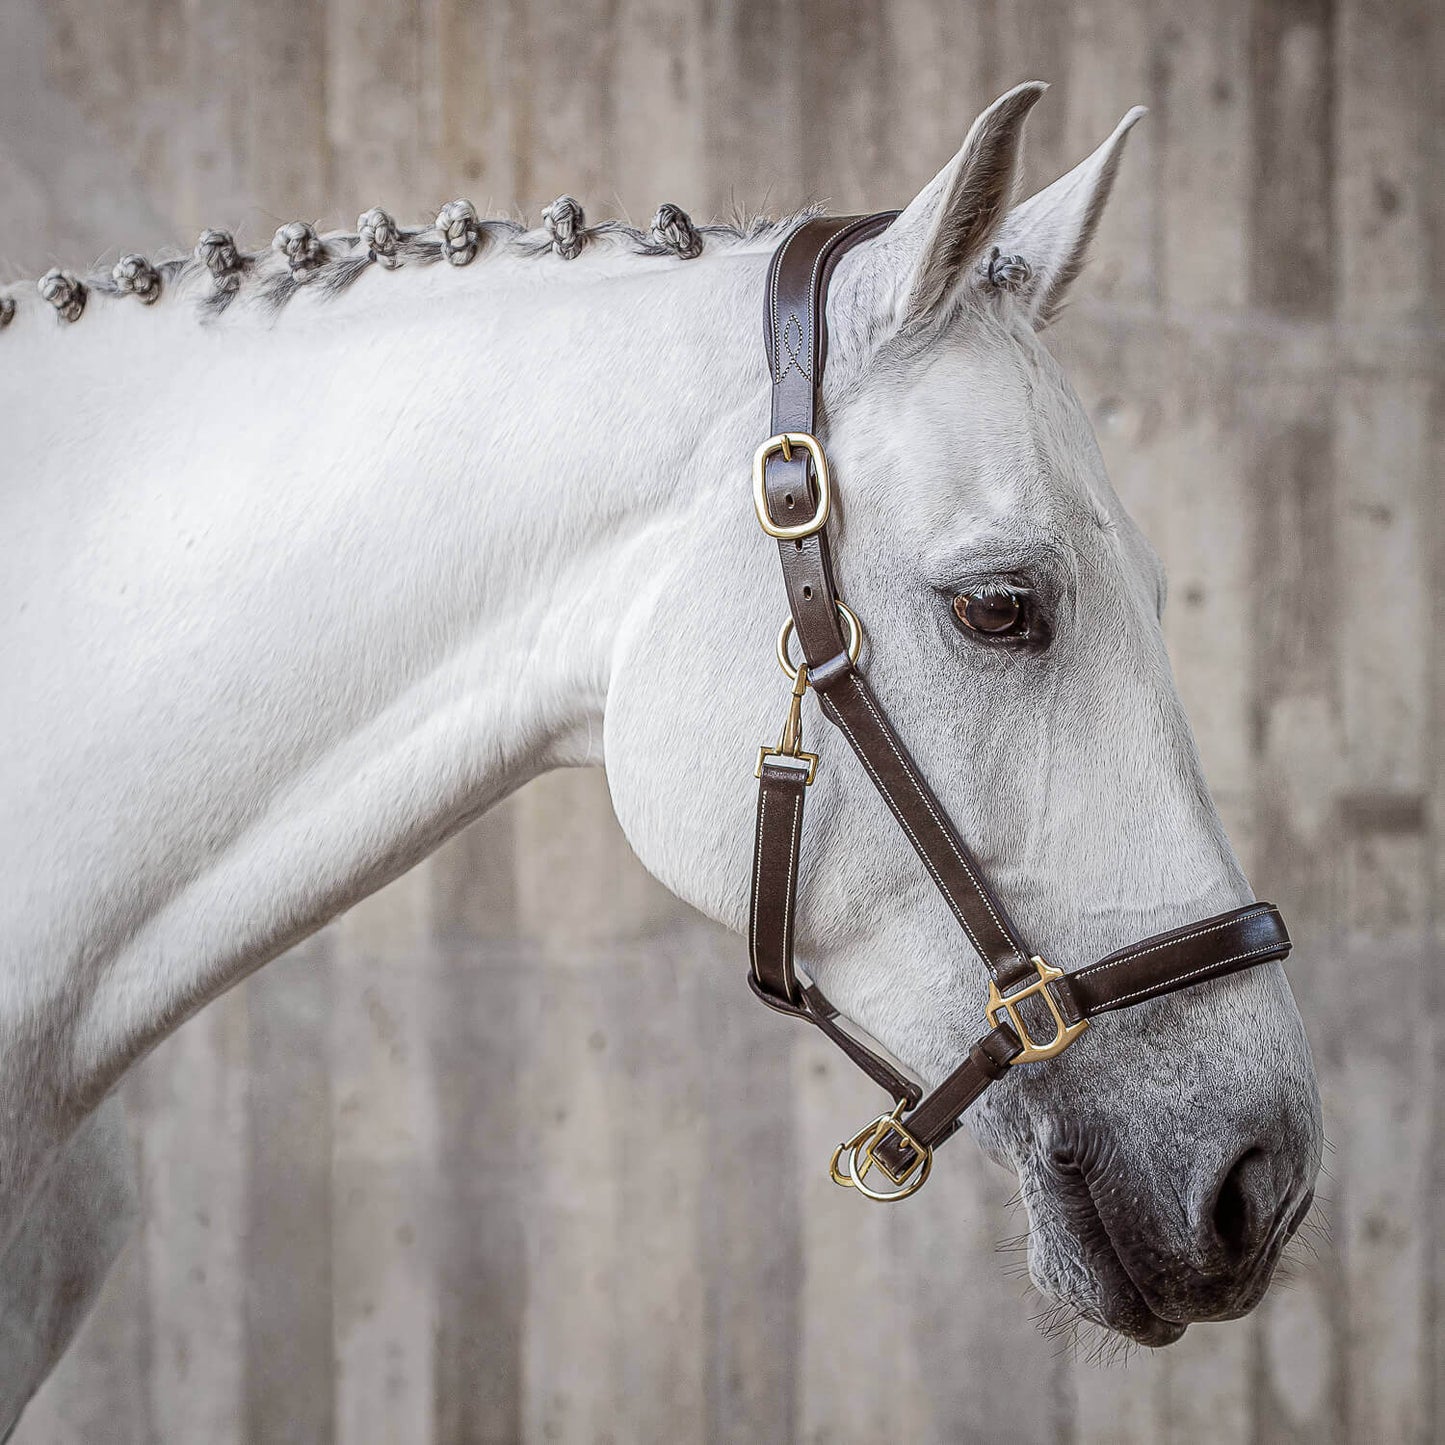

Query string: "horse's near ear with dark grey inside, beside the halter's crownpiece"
[868, 81, 1048, 328]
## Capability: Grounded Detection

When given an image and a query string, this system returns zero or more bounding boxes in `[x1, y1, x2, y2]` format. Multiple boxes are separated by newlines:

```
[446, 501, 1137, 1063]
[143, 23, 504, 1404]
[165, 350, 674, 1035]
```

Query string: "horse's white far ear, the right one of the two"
[993, 105, 1146, 327]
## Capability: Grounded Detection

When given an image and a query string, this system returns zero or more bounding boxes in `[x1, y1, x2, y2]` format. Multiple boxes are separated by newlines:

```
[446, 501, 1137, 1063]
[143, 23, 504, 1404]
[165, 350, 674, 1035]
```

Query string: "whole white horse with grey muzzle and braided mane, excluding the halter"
[0, 85, 1321, 1429]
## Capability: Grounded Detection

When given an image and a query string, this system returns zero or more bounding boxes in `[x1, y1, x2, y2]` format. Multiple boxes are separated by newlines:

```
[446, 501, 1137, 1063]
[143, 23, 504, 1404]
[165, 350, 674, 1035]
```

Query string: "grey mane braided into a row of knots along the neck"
[0, 195, 822, 332]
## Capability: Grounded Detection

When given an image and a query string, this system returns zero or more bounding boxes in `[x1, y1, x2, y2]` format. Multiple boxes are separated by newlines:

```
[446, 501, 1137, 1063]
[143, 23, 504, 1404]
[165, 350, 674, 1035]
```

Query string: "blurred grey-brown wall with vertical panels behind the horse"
[0, 0, 1445, 1445]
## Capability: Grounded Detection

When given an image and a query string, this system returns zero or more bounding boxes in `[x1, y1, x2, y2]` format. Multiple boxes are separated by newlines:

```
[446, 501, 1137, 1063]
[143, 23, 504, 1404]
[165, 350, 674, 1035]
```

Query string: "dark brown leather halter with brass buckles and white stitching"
[749, 211, 1290, 1199]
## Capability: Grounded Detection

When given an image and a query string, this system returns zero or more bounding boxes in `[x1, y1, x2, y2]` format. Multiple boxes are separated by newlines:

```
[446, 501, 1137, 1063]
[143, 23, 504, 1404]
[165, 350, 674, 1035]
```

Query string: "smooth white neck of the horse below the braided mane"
[0, 245, 764, 1074]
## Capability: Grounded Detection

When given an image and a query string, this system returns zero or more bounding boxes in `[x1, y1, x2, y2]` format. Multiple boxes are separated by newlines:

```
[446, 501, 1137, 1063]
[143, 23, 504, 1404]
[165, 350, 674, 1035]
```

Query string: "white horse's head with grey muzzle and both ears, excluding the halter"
[607, 85, 1322, 1345]
